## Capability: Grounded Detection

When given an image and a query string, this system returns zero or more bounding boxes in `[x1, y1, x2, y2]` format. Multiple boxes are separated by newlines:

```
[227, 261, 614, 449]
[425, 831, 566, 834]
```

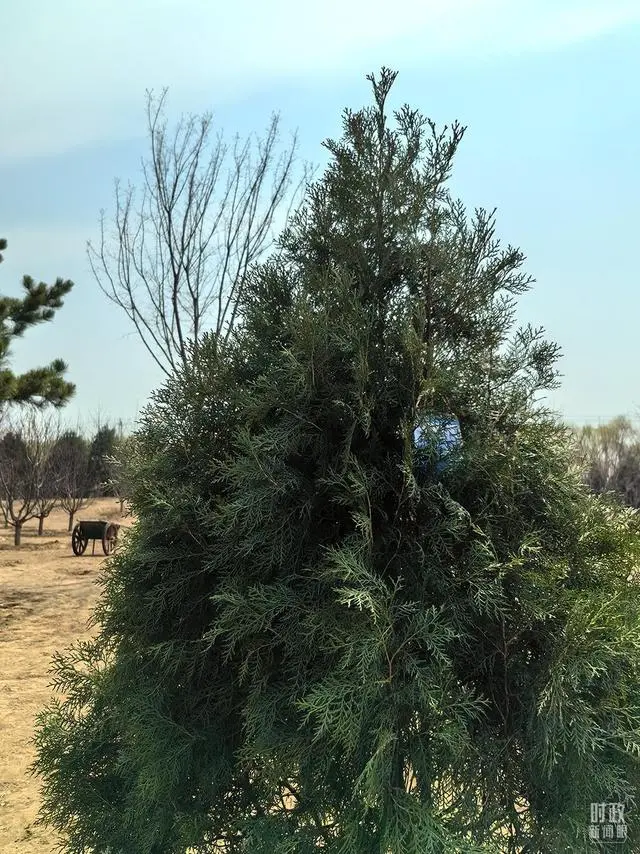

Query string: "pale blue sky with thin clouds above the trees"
[0, 0, 640, 425]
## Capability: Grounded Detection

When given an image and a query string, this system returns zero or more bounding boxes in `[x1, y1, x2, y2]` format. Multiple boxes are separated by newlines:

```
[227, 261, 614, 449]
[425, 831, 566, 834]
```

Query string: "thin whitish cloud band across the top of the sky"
[0, 0, 640, 159]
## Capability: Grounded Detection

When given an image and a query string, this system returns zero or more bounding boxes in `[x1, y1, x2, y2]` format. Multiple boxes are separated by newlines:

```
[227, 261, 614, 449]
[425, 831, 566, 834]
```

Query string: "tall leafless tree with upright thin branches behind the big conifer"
[88, 90, 307, 375]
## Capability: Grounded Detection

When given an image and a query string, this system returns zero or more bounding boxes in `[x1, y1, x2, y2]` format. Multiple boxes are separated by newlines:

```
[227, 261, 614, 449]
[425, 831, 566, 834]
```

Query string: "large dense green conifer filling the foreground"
[34, 69, 640, 854]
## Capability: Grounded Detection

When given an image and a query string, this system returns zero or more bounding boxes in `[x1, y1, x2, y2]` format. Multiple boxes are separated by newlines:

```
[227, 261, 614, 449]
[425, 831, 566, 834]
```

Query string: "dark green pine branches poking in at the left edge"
[0, 238, 75, 410]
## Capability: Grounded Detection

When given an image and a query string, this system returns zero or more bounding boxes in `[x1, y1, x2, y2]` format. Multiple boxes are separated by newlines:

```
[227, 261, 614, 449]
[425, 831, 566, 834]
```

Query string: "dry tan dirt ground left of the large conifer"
[0, 499, 132, 854]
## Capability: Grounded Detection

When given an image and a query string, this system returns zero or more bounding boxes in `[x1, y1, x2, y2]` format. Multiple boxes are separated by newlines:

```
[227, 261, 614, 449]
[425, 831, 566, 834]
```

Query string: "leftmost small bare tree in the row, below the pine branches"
[0, 409, 57, 546]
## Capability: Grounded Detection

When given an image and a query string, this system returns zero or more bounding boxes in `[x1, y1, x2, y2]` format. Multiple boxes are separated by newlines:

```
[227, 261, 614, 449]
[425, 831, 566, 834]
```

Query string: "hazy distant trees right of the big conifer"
[576, 416, 640, 508]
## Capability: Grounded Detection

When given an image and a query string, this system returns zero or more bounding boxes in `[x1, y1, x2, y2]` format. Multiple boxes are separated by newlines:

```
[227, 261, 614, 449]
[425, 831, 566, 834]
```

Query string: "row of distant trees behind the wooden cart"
[0, 416, 132, 546]
